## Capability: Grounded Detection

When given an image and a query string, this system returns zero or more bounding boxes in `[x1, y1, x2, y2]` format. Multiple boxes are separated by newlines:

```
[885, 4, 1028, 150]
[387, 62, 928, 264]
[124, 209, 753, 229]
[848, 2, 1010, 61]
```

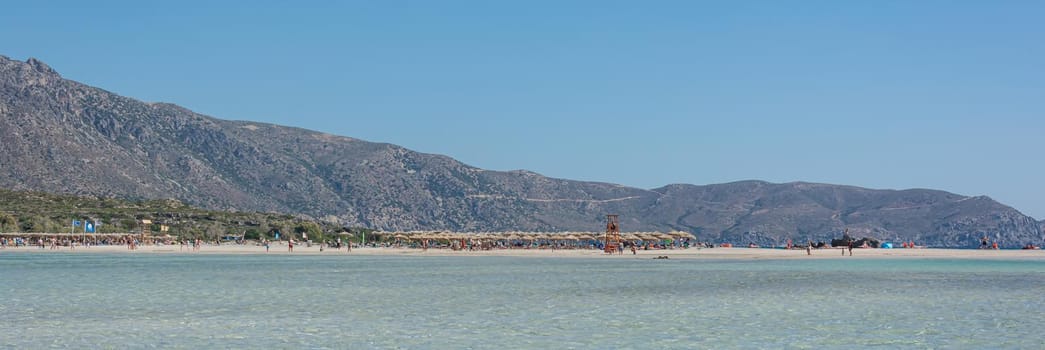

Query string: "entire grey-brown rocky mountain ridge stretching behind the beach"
[0, 56, 1043, 247]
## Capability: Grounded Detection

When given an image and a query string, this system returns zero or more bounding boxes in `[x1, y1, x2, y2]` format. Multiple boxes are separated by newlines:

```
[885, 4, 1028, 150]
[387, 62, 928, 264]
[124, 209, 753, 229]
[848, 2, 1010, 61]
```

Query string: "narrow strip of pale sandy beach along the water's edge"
[0, 243, 1045, 259]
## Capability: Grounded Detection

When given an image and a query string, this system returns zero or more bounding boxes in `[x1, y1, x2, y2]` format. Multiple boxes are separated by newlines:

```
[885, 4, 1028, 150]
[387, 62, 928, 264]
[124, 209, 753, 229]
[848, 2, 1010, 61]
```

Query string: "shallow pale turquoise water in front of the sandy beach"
[0, 252, 1045, 349]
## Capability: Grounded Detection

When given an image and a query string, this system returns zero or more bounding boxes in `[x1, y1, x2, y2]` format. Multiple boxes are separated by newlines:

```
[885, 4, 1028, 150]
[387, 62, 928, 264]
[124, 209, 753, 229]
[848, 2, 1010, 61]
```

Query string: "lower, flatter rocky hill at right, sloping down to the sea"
[650, 182, 1045, 247]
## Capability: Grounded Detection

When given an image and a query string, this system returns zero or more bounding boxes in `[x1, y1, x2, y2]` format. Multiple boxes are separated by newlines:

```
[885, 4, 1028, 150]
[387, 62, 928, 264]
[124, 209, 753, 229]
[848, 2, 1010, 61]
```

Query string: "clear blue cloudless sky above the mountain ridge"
[0, 1, 1045, 218]
